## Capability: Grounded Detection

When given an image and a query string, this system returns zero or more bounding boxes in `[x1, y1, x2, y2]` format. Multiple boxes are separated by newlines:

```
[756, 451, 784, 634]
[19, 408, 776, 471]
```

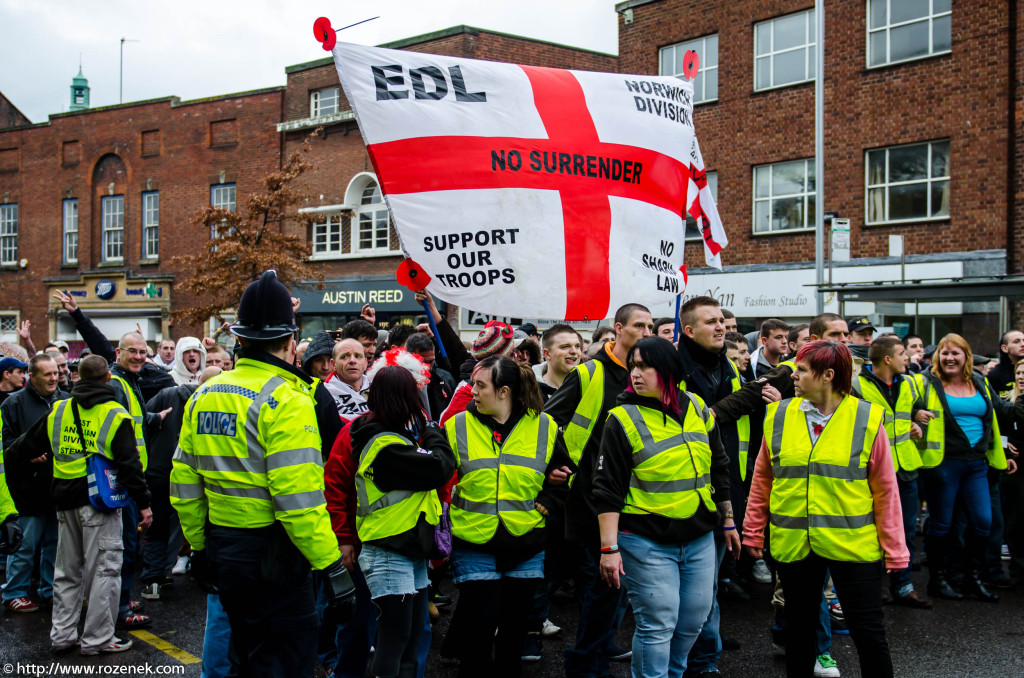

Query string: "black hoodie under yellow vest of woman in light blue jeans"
[594, 392, 729, 544]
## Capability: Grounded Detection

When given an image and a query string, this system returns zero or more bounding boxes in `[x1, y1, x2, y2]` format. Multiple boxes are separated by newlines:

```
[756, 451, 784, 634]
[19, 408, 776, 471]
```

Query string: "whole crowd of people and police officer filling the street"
[0, 271, 1024, 678]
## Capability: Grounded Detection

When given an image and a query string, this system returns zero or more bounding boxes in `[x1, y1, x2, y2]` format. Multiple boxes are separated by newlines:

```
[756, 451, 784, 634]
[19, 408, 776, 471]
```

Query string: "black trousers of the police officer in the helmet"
[206, 523, 316, 678]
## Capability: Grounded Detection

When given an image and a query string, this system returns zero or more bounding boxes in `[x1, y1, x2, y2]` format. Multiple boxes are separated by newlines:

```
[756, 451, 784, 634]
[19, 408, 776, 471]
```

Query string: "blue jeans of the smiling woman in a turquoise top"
[922, 457, 992, 537]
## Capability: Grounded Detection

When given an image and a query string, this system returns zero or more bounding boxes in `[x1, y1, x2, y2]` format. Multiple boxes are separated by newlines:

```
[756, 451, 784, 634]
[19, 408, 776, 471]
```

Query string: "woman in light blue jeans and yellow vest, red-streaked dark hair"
[594, 337, 739, 678]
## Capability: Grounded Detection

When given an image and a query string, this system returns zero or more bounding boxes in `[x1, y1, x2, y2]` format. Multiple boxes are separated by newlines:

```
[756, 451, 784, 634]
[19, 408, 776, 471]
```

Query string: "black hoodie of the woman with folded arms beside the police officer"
[350, 415, 455, 558]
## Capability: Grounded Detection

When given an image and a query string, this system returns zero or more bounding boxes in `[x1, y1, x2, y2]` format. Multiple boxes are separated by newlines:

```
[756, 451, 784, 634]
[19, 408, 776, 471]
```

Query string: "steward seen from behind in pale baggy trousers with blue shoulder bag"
[6, 355, 153, 654]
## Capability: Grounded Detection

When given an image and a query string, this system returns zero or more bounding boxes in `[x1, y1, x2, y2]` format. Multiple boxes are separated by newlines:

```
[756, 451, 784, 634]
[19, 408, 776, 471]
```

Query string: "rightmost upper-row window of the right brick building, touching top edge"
[867, 0, 952, 67]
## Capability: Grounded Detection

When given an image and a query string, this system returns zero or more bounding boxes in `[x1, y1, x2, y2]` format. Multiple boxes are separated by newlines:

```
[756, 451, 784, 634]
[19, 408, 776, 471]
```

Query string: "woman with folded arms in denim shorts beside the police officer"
[351, 365, 455, 678]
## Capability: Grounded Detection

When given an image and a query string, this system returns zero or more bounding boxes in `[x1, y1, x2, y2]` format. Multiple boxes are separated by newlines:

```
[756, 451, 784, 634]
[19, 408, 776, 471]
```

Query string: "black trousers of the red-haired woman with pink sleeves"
[777, 553, 893, 678]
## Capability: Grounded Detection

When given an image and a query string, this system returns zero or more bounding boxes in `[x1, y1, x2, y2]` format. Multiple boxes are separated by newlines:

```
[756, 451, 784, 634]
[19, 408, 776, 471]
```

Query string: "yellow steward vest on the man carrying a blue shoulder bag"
[46, 400, 131, 480]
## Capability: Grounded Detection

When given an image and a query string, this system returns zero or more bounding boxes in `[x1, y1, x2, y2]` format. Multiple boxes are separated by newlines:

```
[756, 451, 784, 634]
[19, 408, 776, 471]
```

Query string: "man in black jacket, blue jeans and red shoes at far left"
[0, 353, 71, 612]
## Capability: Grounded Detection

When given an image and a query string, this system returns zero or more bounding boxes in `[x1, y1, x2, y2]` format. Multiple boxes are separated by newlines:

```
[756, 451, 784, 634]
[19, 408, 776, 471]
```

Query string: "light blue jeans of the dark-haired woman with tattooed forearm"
[618, 532, 716, 678]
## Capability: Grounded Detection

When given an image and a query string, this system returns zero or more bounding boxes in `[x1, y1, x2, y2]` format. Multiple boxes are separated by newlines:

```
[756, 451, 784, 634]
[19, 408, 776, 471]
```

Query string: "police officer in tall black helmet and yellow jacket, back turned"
[171, 270, 354, 676]
